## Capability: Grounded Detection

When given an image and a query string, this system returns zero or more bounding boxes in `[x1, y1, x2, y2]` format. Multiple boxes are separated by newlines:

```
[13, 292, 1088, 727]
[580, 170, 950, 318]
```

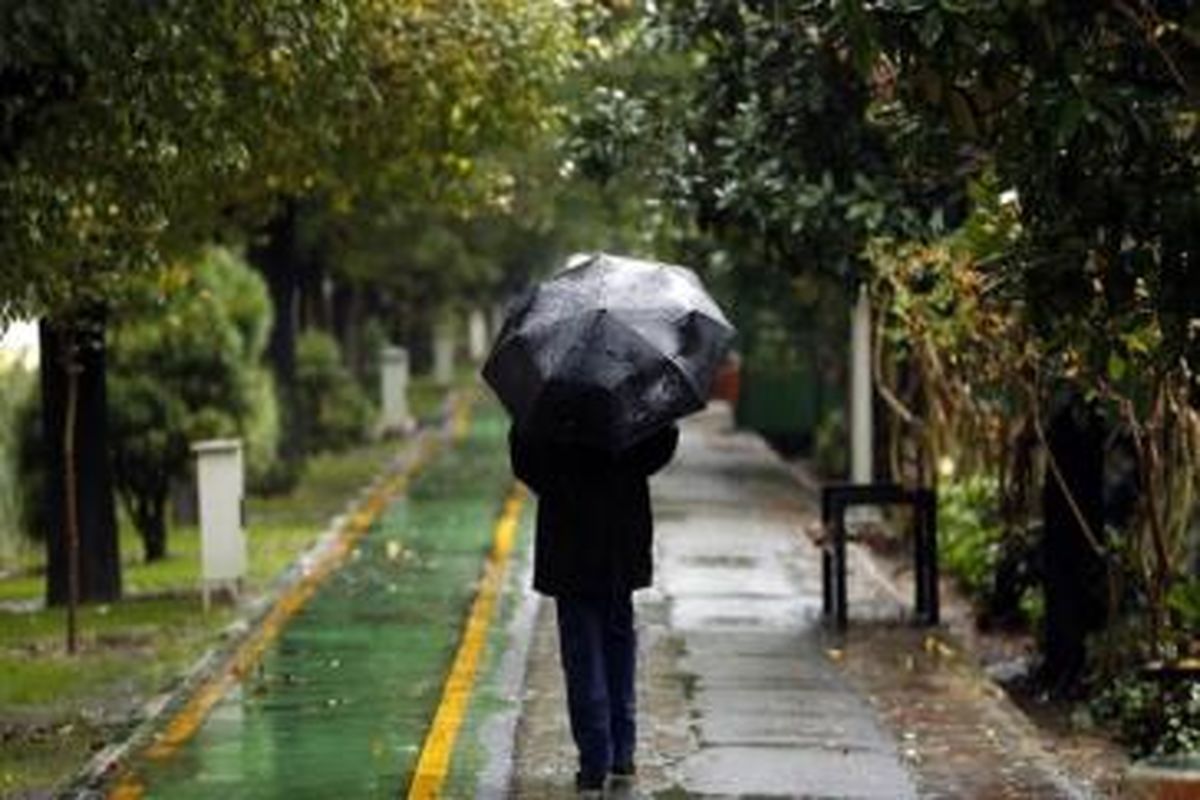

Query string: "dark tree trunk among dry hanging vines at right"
[1040, 396, 1108, 694]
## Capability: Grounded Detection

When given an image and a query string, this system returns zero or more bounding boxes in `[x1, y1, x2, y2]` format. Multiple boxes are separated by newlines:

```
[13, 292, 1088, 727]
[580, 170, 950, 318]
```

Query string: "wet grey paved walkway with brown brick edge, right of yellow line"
[511, 408, 1090, 799]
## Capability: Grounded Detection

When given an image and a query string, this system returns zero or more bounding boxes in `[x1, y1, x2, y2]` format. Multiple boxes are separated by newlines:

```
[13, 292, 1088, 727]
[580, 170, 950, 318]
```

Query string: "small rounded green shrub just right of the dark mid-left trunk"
[295, 331, 374, 452]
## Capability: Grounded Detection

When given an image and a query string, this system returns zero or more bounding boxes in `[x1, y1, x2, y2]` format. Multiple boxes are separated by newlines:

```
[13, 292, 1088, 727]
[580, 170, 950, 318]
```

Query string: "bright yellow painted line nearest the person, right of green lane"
[408, 483, 526, 800]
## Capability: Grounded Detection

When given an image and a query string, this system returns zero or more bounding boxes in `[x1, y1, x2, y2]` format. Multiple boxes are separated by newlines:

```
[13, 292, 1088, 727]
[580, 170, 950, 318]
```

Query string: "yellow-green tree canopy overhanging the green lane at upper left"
[0, 0, 570, 326]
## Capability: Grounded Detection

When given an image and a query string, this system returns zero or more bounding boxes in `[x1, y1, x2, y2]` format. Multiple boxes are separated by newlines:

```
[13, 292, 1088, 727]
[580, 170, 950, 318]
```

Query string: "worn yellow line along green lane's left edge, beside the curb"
[108, 431, 451, 800]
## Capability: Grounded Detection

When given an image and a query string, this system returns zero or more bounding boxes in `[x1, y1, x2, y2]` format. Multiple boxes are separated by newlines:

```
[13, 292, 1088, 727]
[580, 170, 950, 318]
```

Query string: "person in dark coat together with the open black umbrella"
[484, 253, 733, 798]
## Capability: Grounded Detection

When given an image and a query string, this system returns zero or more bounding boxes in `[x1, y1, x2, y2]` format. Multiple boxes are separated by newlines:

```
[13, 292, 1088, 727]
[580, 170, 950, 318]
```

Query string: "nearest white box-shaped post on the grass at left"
[192, 439, 246, 610]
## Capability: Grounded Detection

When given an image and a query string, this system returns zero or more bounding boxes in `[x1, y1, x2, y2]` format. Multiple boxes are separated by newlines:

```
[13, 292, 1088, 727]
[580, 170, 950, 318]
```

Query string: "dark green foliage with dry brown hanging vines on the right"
[575, 0, 1200, 710]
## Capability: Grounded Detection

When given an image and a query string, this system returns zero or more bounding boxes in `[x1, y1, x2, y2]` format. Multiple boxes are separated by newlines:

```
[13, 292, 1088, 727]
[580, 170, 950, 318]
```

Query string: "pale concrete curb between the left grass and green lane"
[63, 391, 469, 800]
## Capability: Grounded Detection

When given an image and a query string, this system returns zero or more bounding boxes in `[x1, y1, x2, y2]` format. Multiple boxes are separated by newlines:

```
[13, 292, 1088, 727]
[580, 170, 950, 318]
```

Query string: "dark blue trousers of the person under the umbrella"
[557, 593, 637, 781]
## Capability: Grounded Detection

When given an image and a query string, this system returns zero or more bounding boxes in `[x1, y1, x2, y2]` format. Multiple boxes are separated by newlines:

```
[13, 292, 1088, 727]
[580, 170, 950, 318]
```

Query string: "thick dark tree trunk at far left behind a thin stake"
[40, 311, 121, 606]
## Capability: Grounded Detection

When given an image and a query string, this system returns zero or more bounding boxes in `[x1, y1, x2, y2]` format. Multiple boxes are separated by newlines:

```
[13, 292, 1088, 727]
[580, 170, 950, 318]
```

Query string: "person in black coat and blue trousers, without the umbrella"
[510, 412, 679, 796]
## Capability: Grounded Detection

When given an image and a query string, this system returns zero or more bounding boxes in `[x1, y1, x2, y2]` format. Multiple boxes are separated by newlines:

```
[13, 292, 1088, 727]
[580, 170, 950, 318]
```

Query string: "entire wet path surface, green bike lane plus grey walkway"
[98, 405, 1105, 800]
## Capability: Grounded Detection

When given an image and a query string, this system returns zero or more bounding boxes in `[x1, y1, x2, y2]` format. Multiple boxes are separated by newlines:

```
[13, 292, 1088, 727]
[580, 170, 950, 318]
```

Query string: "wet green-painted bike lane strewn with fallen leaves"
[109, 404, 529, 800]
